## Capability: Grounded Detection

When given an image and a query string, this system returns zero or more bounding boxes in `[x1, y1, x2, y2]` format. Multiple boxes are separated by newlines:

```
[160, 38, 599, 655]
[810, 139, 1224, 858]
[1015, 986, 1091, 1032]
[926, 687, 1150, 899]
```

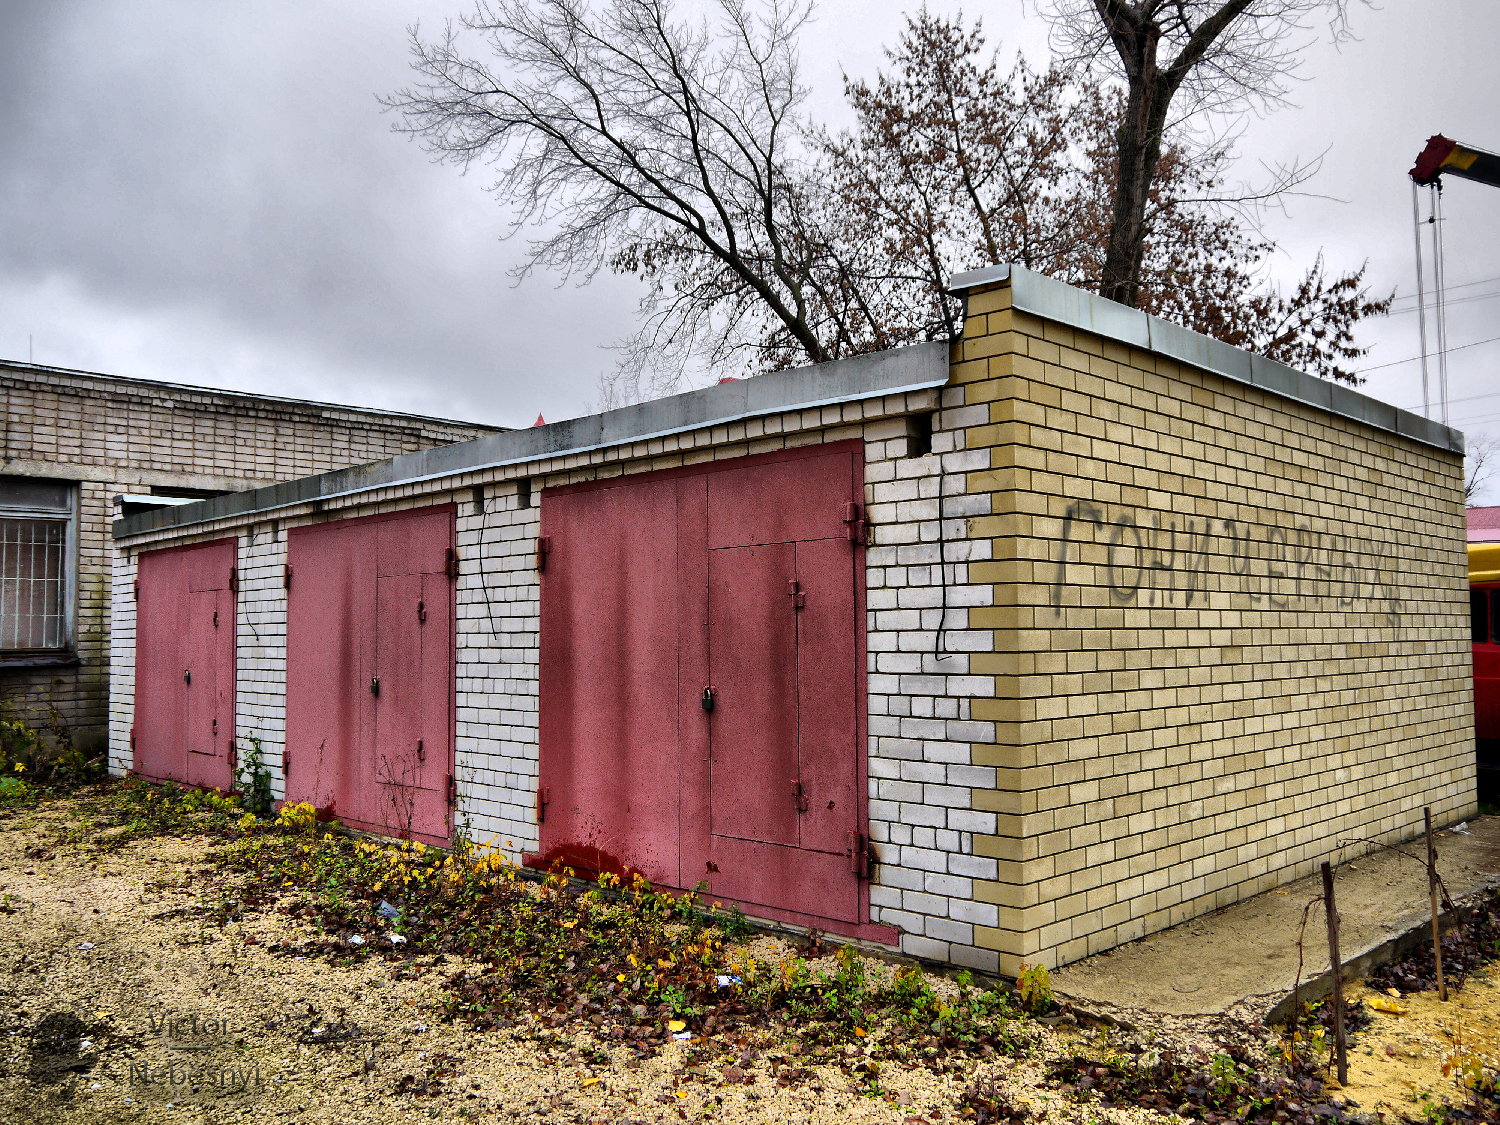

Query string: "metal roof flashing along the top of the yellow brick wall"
[947, 266, 1464, 455]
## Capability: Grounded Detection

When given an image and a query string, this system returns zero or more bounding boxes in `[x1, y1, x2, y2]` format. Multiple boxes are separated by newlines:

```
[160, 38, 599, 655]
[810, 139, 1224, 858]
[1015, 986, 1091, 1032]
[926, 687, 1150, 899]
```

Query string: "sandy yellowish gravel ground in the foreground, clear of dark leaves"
[0, 803, 1500, 1125]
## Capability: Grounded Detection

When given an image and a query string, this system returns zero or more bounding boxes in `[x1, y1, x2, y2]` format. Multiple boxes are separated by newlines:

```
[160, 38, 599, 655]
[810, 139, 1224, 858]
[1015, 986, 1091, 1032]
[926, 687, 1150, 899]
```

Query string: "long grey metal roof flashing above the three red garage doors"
[114, 341, 950, 539]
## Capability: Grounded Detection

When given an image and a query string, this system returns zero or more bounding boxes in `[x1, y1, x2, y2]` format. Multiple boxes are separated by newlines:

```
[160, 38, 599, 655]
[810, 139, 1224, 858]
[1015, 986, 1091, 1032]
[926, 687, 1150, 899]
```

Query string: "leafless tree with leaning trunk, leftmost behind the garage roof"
[386, 0, 830, 384]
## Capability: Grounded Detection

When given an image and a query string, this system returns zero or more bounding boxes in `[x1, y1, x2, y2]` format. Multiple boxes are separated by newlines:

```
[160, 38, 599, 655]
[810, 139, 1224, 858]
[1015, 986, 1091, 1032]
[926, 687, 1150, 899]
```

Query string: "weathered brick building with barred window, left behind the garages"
[0, 362, 495, 759]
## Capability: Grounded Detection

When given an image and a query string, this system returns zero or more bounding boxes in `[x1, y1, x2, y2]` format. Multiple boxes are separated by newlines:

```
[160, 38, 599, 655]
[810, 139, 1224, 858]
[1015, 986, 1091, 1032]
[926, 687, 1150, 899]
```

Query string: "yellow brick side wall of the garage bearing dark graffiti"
[953, 285, 1475, 974]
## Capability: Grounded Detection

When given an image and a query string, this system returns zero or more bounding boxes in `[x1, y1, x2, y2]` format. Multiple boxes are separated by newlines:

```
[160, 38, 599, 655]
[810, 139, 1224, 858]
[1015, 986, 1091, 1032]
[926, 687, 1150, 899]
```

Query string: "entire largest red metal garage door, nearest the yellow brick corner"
[539, 444, 869, 926]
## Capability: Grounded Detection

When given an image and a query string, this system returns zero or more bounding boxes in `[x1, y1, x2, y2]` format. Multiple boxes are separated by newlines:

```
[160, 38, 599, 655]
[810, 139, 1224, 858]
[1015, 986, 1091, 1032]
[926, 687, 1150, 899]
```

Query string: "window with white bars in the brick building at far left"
[0, 477, 74, 653]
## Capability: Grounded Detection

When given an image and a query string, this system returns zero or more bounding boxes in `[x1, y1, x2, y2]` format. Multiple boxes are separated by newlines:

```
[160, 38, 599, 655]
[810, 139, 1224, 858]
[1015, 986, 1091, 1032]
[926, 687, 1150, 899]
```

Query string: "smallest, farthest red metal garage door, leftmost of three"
[132, 539, 236, 791]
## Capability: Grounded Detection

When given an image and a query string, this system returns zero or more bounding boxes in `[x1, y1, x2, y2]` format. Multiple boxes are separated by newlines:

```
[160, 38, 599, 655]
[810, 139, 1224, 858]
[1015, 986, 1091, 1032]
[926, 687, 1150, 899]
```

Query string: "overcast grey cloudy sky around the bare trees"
[0, 0, 1500, 492]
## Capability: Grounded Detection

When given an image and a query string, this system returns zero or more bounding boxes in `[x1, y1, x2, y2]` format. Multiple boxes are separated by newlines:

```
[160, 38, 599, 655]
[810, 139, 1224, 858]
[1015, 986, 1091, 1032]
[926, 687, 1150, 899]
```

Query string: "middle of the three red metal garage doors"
[285, 506, 455, 842]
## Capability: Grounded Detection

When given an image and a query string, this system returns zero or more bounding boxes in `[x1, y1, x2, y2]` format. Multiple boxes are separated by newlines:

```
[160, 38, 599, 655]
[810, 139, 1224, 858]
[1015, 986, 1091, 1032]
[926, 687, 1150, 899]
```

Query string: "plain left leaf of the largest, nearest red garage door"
[540, 480, 680, 887]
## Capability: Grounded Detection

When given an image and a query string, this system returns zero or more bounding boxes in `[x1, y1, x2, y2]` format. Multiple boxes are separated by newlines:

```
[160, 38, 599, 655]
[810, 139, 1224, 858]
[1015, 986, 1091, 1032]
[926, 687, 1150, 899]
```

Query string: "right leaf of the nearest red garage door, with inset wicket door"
[708, 455, 864, 923]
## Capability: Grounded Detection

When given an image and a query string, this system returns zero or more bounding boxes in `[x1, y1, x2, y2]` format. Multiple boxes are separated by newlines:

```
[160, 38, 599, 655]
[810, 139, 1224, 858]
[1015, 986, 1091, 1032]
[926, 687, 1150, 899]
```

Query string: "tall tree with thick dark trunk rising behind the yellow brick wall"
[1044, 0, 1349, 306]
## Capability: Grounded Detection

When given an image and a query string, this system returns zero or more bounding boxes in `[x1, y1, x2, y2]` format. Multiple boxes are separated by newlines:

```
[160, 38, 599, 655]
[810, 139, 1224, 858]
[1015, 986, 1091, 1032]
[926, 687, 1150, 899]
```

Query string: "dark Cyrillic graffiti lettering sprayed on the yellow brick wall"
[1052, 500, 1403, 627]
